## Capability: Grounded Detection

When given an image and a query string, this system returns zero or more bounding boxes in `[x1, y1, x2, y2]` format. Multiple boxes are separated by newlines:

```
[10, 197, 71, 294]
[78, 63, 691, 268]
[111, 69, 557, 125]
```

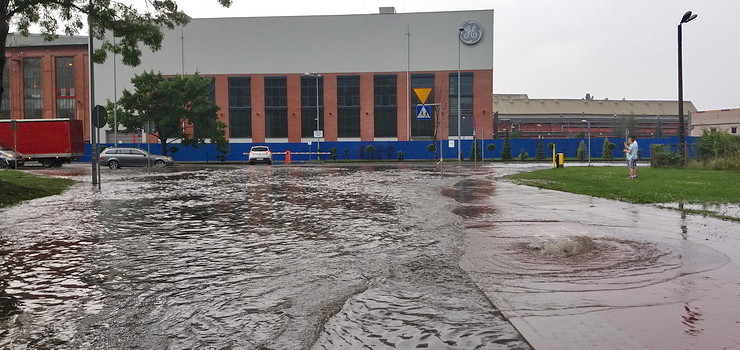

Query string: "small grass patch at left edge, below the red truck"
[0, 170, 75, 208]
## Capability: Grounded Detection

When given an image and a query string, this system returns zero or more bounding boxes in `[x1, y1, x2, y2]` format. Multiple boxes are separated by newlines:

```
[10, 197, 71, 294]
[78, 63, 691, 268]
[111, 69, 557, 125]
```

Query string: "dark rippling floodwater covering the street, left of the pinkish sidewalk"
[0, 165, 532, 349]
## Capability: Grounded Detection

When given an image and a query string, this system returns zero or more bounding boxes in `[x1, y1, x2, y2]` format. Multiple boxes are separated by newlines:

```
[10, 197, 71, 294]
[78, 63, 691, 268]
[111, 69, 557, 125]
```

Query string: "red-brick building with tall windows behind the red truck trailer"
[0, 33, 90, 139]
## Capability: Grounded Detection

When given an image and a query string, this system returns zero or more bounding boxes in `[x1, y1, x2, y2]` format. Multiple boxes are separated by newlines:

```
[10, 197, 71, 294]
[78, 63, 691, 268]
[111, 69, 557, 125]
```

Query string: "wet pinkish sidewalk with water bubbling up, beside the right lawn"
[460, 180, 740, 349]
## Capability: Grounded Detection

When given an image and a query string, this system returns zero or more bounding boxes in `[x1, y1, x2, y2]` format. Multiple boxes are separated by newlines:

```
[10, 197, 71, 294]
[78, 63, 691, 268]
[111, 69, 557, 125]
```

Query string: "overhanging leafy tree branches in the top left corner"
[0, 0, 232, 106]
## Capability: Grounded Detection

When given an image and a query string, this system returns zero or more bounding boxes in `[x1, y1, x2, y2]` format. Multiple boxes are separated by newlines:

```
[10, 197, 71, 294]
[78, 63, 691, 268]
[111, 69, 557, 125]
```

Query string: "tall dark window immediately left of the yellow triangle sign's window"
[374, 75, 398, 137]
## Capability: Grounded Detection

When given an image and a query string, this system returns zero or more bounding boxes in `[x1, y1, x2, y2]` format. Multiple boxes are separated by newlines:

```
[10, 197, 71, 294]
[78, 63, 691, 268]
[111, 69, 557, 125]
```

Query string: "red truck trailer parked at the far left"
[0, 118, 85, 168]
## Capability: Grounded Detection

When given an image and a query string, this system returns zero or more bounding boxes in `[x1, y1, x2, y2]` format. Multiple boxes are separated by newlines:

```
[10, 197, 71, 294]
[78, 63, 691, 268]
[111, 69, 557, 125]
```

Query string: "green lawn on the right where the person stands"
[506, 166, 740, 204]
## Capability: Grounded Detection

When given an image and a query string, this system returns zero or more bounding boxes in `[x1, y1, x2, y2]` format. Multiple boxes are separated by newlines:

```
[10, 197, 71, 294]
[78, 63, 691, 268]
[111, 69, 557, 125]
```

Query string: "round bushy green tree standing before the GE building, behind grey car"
[108, 71, 229, 155]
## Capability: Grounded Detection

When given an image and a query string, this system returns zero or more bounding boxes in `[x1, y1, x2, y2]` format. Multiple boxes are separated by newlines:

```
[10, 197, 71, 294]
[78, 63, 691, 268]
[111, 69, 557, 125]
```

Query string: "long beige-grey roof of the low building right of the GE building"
[493, 94, 697, 116]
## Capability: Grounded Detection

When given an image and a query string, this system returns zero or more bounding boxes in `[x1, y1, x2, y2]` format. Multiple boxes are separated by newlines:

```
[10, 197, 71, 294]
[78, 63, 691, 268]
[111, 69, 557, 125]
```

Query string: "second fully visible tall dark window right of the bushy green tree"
[265, 77, 288, 138]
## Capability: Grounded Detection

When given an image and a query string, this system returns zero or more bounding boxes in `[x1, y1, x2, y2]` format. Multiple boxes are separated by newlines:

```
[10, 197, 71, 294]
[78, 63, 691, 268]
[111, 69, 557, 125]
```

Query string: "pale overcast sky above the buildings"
[146, 0, 740, 110]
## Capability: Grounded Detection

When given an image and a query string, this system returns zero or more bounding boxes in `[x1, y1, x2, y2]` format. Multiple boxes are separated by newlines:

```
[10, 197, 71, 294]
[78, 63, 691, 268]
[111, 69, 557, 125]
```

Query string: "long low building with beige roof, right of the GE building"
[493, 94, 696, 138]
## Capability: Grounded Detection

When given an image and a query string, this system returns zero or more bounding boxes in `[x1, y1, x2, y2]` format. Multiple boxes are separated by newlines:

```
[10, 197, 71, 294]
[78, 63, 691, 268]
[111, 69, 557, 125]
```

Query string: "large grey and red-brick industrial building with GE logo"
[95, 8, 493, 144]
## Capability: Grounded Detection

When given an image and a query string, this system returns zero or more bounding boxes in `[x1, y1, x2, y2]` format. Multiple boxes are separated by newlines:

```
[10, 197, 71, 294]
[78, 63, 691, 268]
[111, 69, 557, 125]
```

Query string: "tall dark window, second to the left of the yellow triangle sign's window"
[337, 75, 360, 137]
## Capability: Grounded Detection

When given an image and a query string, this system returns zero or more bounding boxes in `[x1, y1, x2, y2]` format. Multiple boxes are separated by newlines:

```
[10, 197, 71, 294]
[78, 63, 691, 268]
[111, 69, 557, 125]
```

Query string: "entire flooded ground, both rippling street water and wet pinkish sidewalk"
[0, 163, 740, 349]
